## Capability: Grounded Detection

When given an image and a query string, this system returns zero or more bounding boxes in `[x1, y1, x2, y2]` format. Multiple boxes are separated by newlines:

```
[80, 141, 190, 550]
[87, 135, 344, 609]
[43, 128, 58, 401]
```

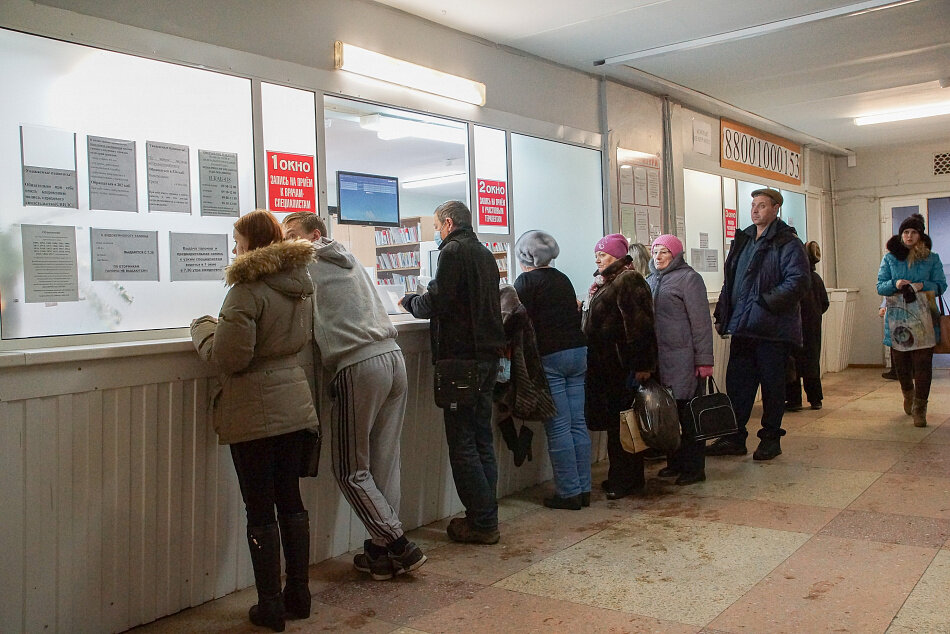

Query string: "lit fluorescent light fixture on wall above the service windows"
[333, 41, 485, 106]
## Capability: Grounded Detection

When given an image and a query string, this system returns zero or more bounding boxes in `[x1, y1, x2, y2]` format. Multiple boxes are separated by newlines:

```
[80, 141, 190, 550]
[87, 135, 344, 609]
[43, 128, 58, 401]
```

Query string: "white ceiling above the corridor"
[379, 0, 950, 150]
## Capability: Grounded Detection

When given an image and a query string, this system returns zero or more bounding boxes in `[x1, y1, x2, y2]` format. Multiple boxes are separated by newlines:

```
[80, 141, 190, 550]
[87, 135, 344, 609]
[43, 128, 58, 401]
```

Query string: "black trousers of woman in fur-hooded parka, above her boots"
[231, 430, 310, 526]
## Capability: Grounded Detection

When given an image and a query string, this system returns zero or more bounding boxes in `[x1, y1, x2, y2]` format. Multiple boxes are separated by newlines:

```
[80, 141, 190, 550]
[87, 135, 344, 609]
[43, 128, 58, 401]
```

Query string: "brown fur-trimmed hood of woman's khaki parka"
[224, 240, 314, 296]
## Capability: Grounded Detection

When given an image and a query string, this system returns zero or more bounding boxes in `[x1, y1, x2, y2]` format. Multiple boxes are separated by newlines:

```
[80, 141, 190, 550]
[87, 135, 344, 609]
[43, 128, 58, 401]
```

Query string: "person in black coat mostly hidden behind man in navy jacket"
[785, 240, 830, 412]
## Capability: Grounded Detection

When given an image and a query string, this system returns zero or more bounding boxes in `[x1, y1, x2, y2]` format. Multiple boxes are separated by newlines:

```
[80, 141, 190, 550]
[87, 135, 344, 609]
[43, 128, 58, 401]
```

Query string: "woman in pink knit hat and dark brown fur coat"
[583, 233, 656, 500]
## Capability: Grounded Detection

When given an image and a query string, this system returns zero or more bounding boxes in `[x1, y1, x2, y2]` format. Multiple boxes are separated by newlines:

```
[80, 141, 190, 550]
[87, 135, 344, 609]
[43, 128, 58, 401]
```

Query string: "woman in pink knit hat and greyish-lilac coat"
[647, 234, 713, 485]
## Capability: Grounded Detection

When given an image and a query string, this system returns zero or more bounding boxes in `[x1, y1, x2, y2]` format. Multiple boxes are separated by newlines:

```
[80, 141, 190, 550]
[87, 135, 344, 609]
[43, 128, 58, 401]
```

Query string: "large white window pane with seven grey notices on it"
[0, 30, 255, 340]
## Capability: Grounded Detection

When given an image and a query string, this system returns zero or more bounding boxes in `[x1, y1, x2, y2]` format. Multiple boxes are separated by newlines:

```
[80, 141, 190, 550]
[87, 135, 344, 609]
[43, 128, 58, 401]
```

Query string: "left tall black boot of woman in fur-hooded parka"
[247, 524, 284, 632]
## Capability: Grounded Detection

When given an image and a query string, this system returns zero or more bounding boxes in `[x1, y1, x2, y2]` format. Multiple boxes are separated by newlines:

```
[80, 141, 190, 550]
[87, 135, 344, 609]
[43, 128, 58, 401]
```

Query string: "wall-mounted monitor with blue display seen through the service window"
[336, 172, 399, 227]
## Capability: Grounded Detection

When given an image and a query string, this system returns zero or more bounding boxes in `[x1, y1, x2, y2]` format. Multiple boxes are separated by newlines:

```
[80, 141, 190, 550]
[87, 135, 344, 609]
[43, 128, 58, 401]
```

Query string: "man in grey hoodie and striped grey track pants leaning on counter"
[283, 212, 426, 580]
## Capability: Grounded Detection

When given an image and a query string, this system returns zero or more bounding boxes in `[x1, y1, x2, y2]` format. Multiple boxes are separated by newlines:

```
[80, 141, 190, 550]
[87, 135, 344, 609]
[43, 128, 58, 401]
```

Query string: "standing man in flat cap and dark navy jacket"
[706, 188, 809, 460]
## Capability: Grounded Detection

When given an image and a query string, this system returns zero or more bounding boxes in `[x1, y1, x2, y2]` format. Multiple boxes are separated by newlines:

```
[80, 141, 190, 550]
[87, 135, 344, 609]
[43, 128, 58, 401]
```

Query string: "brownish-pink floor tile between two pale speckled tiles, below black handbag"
[643, 495, 841, 534]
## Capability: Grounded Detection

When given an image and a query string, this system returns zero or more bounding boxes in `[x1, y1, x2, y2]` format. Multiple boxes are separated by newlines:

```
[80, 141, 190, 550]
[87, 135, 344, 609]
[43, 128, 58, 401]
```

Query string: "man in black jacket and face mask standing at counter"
[399, 200, 505, 544]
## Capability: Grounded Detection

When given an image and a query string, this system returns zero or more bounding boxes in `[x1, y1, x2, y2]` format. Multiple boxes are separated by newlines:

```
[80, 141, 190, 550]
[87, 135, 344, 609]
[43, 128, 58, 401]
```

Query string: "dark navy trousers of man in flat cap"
[726, 337, 788, 445]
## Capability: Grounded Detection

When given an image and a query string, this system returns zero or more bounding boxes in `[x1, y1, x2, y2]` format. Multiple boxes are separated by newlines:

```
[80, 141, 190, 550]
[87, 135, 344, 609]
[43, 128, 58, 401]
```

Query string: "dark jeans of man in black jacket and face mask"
[442, 359, 498, 530]
